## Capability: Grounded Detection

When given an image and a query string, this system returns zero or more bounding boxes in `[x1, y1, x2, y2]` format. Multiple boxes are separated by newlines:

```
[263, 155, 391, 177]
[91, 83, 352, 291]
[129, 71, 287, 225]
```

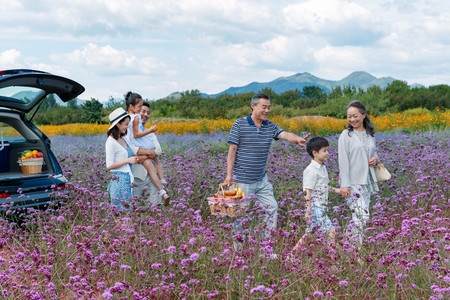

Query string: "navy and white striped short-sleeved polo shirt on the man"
[228, 115, 284, 183]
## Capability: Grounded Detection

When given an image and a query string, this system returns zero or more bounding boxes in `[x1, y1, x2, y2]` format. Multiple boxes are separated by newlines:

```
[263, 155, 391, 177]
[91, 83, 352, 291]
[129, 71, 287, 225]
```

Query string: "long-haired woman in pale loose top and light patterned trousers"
[338, 100, 378, 248]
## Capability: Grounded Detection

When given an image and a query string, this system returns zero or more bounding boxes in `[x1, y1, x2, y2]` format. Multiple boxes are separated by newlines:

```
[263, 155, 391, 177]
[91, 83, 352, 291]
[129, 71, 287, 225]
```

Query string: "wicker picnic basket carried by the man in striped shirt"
[207, 182, 250, 217]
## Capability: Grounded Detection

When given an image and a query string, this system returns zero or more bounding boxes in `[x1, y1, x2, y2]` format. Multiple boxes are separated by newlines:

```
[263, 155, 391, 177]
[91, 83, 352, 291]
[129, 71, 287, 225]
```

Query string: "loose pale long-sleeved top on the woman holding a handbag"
[338, 129, 378, 187]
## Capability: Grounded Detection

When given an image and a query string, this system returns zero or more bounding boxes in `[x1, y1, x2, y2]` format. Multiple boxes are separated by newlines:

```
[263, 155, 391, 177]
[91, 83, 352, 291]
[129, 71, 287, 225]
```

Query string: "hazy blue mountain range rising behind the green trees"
[202, 71, 396, 97]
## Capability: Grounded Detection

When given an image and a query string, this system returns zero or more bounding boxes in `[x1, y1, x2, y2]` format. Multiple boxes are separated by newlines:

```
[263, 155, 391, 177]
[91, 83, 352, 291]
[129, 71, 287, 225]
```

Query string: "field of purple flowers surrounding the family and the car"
[0, 131, 450, 299]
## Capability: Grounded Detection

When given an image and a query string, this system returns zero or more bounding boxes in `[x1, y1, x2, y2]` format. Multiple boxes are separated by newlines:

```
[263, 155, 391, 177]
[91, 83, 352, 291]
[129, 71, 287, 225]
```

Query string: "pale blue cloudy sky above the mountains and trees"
[0, 0, 450, 101]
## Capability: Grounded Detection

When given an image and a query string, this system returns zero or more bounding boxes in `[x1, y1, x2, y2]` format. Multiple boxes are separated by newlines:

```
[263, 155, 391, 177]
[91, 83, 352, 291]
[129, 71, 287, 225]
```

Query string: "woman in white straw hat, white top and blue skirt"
[105, 108, 156, 210]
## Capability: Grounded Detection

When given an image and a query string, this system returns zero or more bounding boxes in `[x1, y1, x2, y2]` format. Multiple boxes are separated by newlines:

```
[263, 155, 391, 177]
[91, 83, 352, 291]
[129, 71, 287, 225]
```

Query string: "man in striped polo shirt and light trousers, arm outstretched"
[225, 93, 309, 248]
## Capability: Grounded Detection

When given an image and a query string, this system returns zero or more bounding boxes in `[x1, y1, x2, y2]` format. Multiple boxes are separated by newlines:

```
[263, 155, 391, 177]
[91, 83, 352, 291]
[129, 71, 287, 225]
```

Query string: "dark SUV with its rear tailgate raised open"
[0, 70, 84, 210]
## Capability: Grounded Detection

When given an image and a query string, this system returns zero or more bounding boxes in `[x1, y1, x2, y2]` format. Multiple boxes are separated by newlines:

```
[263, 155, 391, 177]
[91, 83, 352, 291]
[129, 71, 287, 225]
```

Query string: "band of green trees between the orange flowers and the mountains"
[34, 80, 450, 125]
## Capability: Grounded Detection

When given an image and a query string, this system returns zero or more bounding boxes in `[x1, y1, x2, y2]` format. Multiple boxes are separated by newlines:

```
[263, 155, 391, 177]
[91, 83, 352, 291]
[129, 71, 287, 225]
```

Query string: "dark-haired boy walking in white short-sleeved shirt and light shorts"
[292, 136, 341, 254]
